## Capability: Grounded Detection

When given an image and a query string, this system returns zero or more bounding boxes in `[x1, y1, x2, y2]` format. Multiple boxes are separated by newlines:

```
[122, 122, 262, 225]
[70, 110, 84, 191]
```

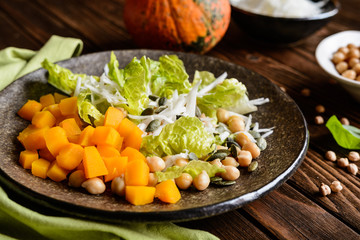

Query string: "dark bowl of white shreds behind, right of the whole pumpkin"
[230, 0, 340, 44]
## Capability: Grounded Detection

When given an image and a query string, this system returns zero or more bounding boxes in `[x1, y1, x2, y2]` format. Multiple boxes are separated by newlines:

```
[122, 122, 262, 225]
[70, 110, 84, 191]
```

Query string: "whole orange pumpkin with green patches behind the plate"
[124, 0, 231, 53]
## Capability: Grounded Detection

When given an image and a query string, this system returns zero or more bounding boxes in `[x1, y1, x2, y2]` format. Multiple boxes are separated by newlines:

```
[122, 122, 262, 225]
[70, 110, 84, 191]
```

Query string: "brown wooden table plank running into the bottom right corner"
[244, 184, 359, 239]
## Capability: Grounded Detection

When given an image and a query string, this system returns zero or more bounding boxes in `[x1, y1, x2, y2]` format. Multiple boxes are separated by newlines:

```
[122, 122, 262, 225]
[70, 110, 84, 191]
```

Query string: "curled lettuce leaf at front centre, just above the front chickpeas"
[140, 117, 215, 158]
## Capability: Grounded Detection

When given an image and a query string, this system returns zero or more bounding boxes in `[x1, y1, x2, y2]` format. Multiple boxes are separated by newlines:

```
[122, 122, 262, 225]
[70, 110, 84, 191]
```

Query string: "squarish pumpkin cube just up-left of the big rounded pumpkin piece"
[45, 126, 69, 157]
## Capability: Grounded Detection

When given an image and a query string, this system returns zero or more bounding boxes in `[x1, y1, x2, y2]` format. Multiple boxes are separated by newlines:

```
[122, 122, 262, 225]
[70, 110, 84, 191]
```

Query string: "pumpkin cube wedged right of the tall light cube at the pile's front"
[103, 156, 128, 182]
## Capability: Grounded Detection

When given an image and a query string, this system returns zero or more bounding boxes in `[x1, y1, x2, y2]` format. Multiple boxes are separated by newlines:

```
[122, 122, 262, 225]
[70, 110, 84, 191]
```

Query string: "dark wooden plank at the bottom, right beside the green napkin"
[177, 211, 271, 240]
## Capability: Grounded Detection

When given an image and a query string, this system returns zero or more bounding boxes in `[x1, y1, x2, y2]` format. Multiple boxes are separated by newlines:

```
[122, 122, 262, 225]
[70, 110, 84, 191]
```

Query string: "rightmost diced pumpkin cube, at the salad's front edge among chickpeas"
[155, 179, 181, 203]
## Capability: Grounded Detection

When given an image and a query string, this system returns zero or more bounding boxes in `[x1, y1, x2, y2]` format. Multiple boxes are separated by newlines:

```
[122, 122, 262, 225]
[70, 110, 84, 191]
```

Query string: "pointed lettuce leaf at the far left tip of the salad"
[41, 59, 86, 95]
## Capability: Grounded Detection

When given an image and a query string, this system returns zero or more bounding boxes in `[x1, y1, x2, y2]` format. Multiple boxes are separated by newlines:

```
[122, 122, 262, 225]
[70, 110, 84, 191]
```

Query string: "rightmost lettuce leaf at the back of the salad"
[197, 78, 257, 118]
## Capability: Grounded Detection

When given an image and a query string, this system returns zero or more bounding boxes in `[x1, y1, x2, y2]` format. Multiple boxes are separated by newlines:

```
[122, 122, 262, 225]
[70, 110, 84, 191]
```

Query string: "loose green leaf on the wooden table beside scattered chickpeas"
[326, 116, 360, 149]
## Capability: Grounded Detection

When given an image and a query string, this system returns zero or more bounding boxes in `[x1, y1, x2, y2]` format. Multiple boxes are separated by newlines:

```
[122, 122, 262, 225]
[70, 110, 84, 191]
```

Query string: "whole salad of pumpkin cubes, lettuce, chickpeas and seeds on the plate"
[14, 53, 273, 205]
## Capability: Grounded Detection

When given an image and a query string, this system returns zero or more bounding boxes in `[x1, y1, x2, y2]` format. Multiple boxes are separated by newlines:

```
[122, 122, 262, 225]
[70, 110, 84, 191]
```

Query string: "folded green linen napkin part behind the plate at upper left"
[0, 35, 83, 91]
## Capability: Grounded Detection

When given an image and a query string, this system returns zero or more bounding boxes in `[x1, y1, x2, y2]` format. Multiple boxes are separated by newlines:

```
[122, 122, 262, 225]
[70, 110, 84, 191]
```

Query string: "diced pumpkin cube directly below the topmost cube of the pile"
[92, 126, 123, 149]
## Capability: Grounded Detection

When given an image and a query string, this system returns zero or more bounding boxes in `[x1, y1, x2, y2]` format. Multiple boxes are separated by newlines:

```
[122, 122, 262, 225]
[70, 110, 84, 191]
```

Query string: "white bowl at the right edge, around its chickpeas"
[315, 31, 360, 102]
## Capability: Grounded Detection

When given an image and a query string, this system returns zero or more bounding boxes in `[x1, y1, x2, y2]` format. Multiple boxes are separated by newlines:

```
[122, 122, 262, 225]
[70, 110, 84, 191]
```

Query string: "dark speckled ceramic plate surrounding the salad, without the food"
[0, 50, 309, 222]
